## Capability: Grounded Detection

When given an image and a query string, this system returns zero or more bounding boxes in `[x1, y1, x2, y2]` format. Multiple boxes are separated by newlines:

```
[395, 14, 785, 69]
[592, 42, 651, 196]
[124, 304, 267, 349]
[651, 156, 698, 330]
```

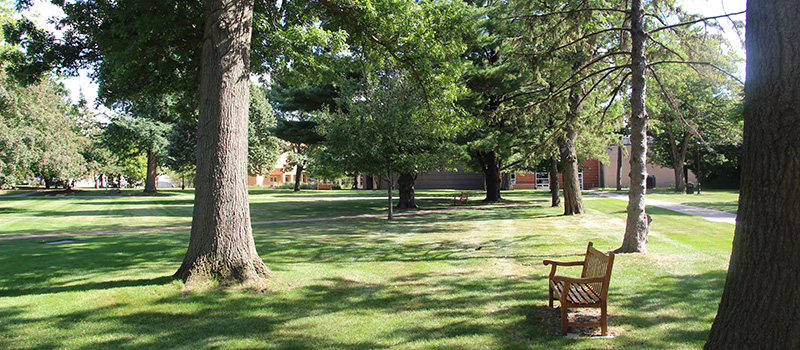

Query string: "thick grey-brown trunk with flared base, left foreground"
[175, 0, 272, 288]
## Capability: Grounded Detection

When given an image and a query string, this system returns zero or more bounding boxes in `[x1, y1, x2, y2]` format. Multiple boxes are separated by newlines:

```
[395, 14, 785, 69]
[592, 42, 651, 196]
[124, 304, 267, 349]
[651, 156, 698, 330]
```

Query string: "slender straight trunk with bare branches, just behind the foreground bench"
[616, 0, 650, 253]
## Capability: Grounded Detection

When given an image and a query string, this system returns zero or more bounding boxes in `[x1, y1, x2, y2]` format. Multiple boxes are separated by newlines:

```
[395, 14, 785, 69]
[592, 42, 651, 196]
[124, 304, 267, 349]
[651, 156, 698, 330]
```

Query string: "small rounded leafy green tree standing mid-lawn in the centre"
[321, 72, 453, 216]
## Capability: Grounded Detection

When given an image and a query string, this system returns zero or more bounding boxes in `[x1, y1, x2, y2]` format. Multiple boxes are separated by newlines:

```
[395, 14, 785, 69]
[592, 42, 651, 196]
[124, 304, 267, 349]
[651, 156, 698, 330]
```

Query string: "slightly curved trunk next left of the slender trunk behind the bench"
[558, 82, 585, 215]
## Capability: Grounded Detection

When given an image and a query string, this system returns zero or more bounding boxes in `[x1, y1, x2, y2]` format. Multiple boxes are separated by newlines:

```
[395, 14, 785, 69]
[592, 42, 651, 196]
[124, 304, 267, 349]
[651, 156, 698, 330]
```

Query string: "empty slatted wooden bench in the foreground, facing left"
[543, 242, 614, 335]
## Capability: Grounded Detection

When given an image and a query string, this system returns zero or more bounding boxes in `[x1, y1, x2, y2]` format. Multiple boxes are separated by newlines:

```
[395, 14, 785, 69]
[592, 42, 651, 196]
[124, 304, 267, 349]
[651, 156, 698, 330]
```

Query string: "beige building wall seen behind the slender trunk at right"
[600, 145, 697, 188]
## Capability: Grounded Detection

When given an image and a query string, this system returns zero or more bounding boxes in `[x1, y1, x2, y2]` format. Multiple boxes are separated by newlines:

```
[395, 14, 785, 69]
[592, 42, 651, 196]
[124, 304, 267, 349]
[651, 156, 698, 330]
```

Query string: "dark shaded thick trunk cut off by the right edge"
[705, 0, 800, 349]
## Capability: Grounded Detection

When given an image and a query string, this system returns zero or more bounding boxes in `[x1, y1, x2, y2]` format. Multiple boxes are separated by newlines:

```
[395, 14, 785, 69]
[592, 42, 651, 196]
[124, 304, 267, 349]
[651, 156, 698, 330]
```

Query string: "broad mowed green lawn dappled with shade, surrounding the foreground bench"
[0, 192, 733, 349]
